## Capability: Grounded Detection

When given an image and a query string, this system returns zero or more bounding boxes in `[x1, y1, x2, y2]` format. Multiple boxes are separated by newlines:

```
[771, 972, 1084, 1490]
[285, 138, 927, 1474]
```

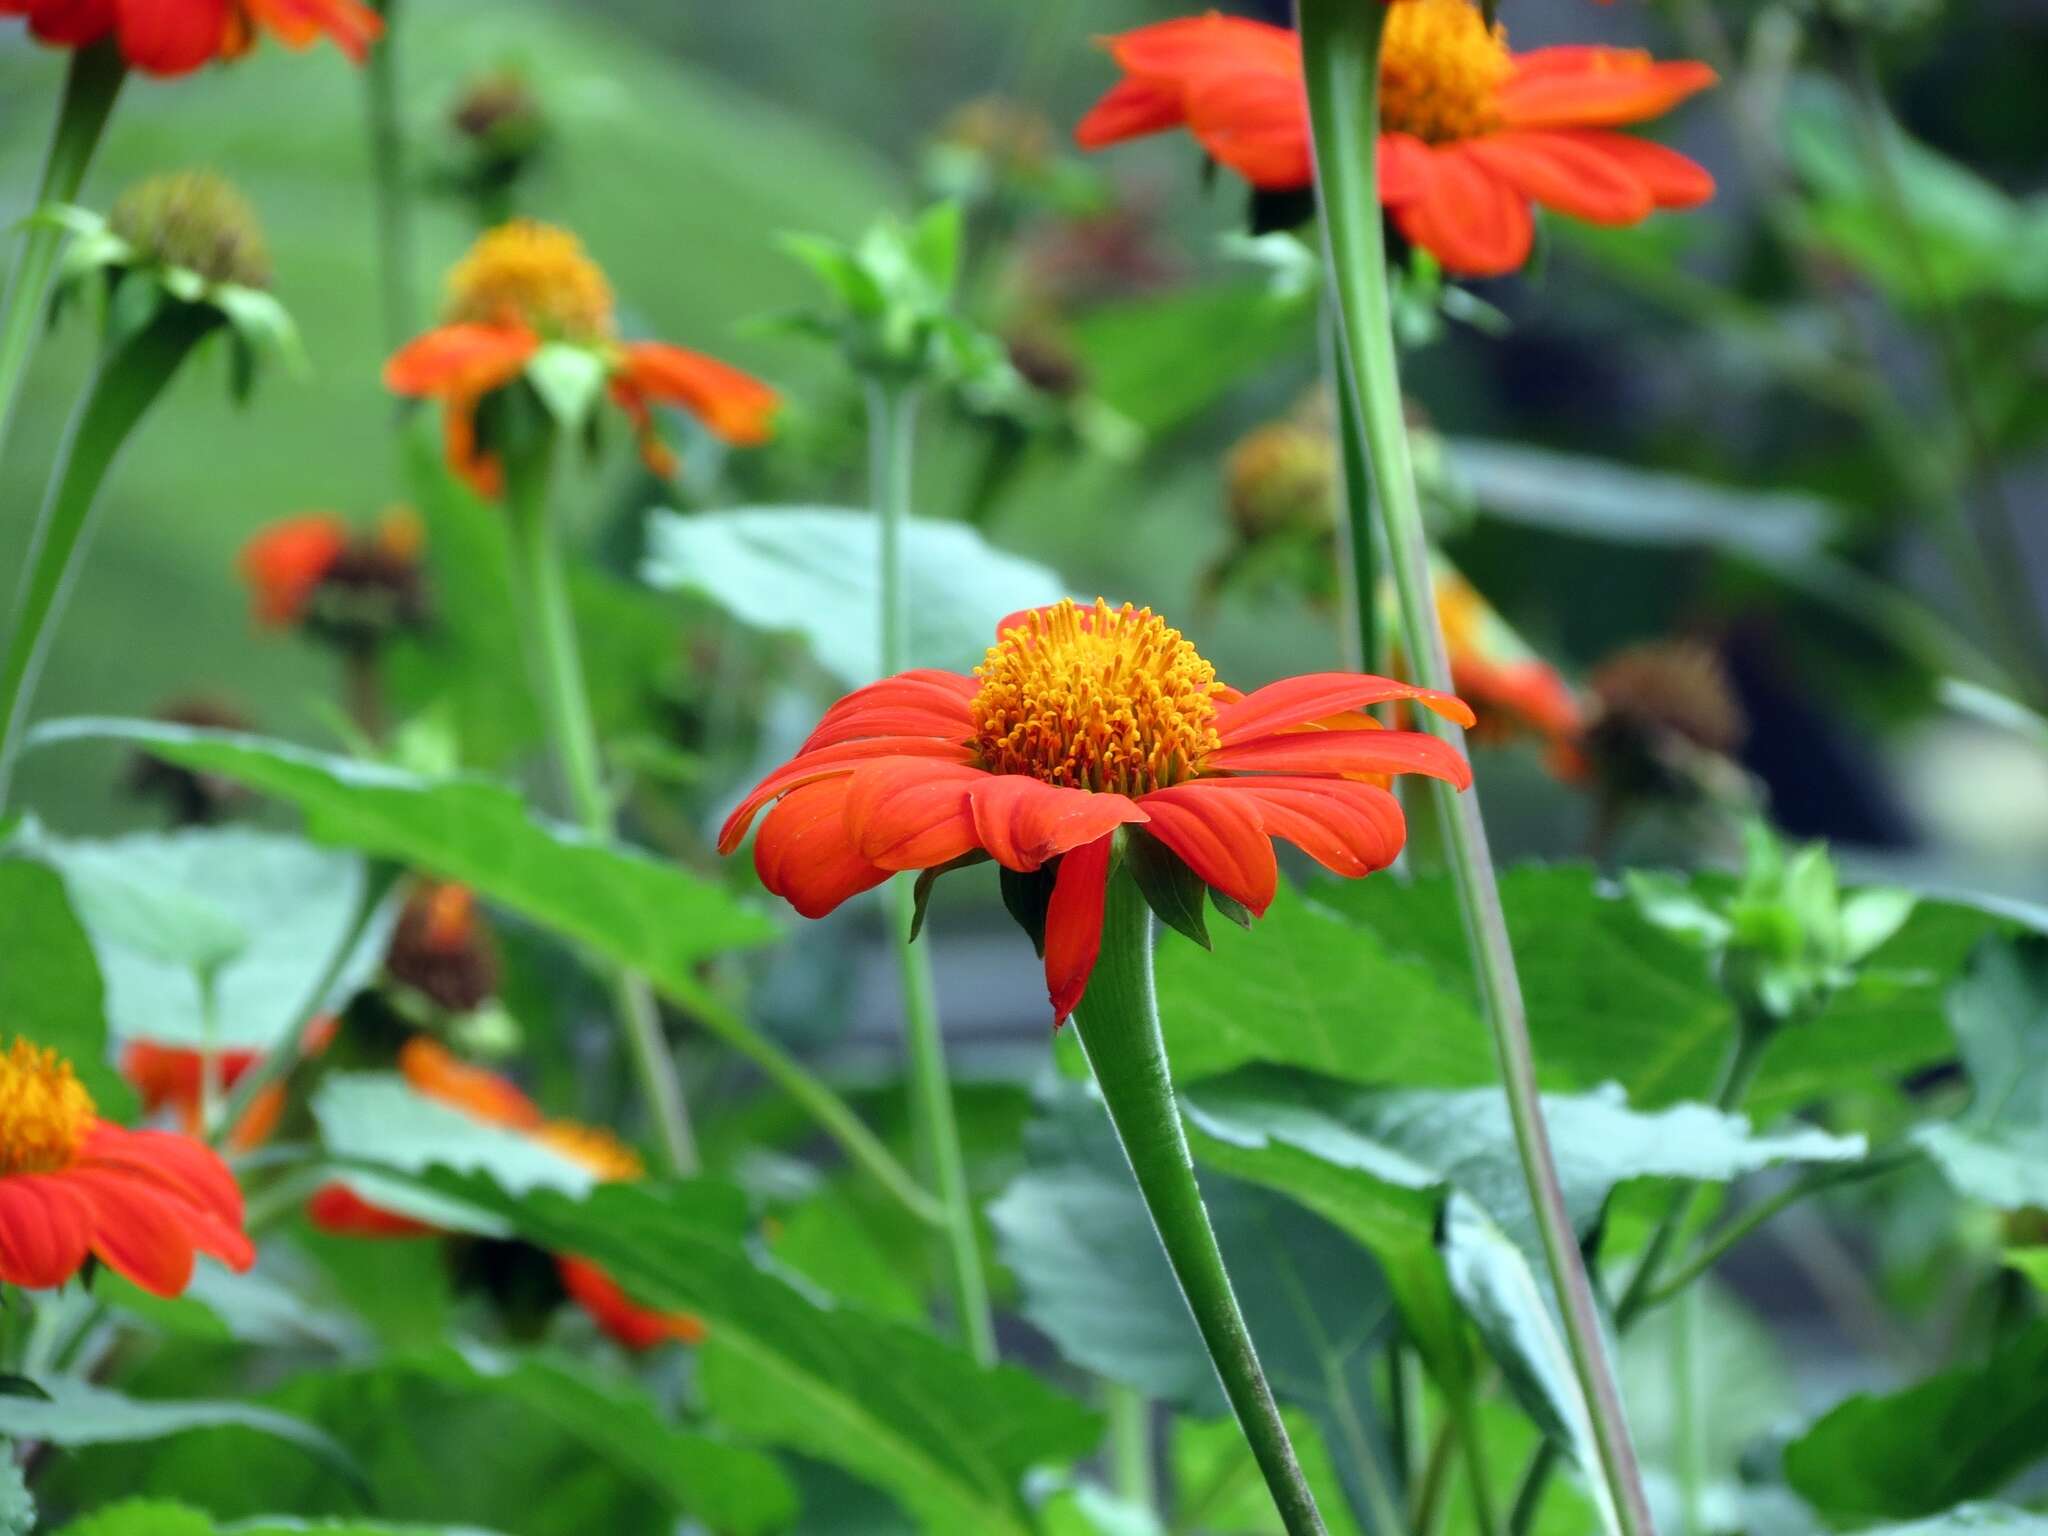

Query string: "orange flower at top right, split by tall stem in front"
[1075, 0, 1714, 276]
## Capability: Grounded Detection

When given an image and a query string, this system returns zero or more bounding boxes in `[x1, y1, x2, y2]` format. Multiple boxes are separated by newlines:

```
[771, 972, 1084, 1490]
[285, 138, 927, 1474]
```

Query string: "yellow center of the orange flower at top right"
[1380, 0, 1513, 143]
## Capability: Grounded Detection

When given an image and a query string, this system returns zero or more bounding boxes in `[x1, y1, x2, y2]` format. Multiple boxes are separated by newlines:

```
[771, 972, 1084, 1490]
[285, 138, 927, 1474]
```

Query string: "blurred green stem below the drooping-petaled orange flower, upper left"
[506, 422, 698, 1174]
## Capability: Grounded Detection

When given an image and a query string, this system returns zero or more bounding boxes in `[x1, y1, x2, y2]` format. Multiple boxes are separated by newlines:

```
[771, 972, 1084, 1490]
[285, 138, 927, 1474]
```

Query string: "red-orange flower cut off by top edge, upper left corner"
[0, 0, 383, 76]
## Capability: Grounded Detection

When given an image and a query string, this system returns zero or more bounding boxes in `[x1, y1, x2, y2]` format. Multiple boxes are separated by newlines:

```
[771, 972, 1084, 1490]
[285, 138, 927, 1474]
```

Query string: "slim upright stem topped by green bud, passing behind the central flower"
[868, 381, 995, 1364]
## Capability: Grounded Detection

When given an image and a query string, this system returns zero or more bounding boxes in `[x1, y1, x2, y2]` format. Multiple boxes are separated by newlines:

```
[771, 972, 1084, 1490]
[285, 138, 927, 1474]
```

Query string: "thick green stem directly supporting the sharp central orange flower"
[1075, 870, 1323, 1536]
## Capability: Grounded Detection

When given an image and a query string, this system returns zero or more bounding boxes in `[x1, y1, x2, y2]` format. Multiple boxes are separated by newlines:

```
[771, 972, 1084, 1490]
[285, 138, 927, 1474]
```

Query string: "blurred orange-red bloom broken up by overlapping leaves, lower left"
[307, 1036, 705, 1350]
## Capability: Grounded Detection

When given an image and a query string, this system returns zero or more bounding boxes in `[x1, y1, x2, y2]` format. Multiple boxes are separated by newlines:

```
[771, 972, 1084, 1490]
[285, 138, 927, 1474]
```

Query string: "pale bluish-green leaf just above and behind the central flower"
[641, 506, 1067, 686]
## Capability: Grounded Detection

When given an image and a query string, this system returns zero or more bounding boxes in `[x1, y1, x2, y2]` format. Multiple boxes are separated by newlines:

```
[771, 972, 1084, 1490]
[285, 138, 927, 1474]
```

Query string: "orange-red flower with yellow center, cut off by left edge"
[0, 1040, 256, 1296]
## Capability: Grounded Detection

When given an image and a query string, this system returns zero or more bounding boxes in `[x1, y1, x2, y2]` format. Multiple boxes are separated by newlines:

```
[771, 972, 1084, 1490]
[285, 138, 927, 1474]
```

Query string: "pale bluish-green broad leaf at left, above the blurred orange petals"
[18, 827, 387, 1051]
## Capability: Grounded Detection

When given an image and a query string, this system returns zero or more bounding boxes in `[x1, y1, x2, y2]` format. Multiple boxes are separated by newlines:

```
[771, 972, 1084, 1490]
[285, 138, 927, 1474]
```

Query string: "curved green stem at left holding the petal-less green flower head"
[0, 299, 221, 809]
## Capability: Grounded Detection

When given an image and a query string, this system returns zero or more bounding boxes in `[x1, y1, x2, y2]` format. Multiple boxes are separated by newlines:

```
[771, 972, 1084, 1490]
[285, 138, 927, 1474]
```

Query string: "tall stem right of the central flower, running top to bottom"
[1296, 0, 1655, 1536]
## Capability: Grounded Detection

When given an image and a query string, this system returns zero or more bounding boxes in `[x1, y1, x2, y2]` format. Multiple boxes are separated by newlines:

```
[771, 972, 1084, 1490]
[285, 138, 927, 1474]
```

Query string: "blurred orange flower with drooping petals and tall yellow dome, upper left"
[385, 219, 776, 496]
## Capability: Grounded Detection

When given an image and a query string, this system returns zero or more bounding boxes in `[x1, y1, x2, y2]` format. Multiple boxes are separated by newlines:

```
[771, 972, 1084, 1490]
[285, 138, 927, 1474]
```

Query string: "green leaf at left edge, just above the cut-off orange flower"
[0, 858, 135, 1120]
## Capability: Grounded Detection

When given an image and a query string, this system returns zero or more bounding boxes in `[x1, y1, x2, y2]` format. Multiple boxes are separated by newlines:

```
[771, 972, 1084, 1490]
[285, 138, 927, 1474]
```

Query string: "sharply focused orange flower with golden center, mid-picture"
[719, 598, 1473, 1024]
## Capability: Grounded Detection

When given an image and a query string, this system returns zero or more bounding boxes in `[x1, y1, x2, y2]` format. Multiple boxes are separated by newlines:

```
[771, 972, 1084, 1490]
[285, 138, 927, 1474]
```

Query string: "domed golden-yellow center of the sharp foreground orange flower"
[973, 598, 1223, 795]
